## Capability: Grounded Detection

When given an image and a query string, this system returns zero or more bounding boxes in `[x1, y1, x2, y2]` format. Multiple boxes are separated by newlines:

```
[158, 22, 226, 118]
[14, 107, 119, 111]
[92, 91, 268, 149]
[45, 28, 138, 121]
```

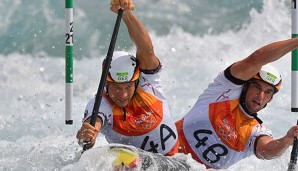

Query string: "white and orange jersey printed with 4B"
[176, 70, 272, 169]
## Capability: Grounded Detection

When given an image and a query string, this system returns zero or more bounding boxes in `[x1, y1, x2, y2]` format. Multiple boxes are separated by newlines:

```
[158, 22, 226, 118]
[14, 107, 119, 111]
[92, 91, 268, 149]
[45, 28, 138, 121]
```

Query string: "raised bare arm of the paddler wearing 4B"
[231, 38, 298, 80]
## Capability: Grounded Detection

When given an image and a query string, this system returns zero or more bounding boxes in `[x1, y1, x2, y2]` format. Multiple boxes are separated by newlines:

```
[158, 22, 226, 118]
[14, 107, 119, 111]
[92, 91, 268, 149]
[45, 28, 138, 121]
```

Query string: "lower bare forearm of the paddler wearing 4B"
[256, 126, 298, 160]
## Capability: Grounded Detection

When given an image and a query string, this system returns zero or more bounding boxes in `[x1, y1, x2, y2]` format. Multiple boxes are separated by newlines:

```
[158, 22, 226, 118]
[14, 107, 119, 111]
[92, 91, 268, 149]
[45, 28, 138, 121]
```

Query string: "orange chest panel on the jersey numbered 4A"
[105, 88, 163, 136]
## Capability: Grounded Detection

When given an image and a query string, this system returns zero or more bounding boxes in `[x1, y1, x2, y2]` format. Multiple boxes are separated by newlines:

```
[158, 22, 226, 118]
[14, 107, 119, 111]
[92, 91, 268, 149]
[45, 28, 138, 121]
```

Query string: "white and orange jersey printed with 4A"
[84, 69, 178, 155]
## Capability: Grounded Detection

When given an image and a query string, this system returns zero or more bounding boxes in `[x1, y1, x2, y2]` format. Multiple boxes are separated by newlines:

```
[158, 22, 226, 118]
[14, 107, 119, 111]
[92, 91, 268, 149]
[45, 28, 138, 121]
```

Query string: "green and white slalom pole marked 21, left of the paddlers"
[65, 0, 73, 125]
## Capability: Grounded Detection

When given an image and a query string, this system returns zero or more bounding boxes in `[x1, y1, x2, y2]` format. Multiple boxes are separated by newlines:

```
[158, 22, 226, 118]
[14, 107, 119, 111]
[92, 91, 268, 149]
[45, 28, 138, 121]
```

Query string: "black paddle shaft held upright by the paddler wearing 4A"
[83, 8, 123, 151]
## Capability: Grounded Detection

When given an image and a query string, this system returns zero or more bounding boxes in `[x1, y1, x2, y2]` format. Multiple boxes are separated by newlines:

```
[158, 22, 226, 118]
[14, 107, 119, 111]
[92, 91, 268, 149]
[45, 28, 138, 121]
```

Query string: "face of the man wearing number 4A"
[106, 82, 136, 107]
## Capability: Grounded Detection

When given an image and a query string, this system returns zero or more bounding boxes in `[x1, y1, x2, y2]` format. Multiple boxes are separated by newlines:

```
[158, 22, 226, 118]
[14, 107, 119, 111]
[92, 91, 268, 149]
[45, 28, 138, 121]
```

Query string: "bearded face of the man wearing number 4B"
[245, 80, 274, 113]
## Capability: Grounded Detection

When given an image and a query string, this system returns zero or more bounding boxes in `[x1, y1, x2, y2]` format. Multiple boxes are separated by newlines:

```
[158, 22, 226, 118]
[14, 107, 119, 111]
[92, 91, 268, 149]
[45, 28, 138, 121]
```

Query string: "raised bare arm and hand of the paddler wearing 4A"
[111, 0, 159, 70]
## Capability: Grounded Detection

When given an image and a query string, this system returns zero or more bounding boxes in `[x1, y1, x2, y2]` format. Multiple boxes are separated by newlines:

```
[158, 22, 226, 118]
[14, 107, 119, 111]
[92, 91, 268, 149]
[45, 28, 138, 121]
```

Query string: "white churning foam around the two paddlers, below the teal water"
[0, 1, 297, 171]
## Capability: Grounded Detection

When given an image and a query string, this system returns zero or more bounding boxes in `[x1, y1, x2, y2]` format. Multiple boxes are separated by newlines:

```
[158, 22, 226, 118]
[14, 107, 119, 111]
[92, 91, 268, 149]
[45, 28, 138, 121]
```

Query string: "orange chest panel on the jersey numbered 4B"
[209, 99, 258, 152]
